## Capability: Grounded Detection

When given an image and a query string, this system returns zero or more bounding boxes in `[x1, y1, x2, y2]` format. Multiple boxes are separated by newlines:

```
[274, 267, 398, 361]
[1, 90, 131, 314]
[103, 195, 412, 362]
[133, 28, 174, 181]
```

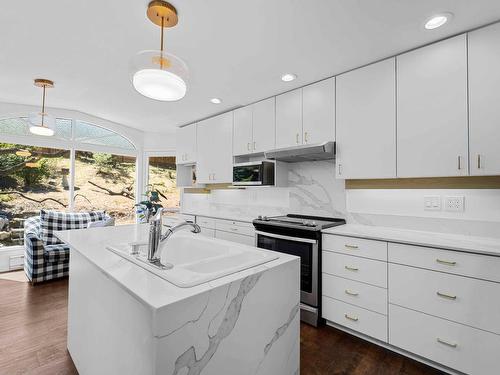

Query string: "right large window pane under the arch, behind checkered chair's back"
[73, 151, 135, 224]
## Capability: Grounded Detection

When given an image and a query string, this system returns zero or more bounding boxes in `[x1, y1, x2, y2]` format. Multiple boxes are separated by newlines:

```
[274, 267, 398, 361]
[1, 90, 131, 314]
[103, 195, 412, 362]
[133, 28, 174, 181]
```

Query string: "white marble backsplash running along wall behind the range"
[181, 160, 500, 237]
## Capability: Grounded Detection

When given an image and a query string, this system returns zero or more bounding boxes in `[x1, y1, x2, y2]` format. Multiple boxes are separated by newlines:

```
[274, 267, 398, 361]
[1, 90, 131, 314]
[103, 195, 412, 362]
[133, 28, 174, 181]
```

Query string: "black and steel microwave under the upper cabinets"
[233, 160, 275, 186]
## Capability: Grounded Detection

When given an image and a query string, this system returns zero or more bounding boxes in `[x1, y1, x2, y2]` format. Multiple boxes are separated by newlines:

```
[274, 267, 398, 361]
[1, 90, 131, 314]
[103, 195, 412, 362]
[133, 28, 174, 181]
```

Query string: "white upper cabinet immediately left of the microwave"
[196, 112, 233, 184]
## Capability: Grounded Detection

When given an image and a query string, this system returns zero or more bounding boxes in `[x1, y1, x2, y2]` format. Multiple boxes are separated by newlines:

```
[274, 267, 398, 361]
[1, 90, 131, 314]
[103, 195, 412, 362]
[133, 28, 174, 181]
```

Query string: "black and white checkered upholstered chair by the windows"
[24, 210, 110, 283]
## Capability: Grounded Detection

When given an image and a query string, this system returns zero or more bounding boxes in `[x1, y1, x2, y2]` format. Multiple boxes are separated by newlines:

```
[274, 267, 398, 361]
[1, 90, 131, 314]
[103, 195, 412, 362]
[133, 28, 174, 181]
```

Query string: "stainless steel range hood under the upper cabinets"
[264, 142, 335, 163]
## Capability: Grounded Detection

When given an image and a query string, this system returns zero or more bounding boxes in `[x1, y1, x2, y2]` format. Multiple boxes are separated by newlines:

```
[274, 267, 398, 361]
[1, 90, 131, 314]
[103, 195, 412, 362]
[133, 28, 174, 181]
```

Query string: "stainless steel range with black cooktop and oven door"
[253, 215, 345, 326]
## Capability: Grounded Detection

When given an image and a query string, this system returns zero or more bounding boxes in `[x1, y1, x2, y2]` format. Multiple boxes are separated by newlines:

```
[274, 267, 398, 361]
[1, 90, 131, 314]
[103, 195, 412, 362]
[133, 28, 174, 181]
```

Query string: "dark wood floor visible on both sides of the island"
[0, 279, 442, 375]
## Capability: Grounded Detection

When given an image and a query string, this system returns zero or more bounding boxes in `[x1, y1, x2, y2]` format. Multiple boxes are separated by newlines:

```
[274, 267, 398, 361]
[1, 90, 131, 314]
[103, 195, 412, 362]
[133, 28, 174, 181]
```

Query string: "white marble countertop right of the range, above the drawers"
[323, 224, 500, 256]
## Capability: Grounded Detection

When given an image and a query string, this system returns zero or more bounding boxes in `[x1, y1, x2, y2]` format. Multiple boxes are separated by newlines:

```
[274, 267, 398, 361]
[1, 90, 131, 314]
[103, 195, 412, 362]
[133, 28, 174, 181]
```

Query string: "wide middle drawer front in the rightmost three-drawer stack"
[389, 264, 500, 334]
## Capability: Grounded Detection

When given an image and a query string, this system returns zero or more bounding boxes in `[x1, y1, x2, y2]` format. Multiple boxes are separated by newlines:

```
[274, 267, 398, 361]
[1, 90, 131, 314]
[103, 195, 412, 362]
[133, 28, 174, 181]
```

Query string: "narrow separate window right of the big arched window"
[147, 156, 180, 213]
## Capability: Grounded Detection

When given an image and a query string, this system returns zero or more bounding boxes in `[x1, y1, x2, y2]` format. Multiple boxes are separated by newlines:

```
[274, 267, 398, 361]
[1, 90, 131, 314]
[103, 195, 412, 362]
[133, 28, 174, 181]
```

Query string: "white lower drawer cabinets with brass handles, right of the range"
[322, 234, 500, 375]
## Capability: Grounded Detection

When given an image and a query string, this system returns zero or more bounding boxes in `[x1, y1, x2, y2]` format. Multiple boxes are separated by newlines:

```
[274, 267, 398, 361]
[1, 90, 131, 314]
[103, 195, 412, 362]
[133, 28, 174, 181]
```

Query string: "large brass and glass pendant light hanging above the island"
[131, 0, 188, 101]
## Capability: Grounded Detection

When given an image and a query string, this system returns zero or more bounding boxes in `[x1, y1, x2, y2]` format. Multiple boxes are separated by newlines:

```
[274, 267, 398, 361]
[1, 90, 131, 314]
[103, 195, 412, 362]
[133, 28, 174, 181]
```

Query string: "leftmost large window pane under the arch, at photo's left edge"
[0, 143, 70, 248]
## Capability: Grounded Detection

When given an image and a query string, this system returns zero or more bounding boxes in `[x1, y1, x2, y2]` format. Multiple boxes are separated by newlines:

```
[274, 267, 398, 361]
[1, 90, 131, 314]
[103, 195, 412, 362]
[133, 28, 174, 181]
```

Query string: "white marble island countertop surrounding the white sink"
[56, 224, 298, 309]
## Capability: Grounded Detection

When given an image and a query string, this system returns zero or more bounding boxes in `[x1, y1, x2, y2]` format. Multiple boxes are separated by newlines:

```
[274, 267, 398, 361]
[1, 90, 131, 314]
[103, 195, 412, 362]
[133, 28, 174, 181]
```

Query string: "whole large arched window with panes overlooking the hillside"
[0, 117, 139, 248]
